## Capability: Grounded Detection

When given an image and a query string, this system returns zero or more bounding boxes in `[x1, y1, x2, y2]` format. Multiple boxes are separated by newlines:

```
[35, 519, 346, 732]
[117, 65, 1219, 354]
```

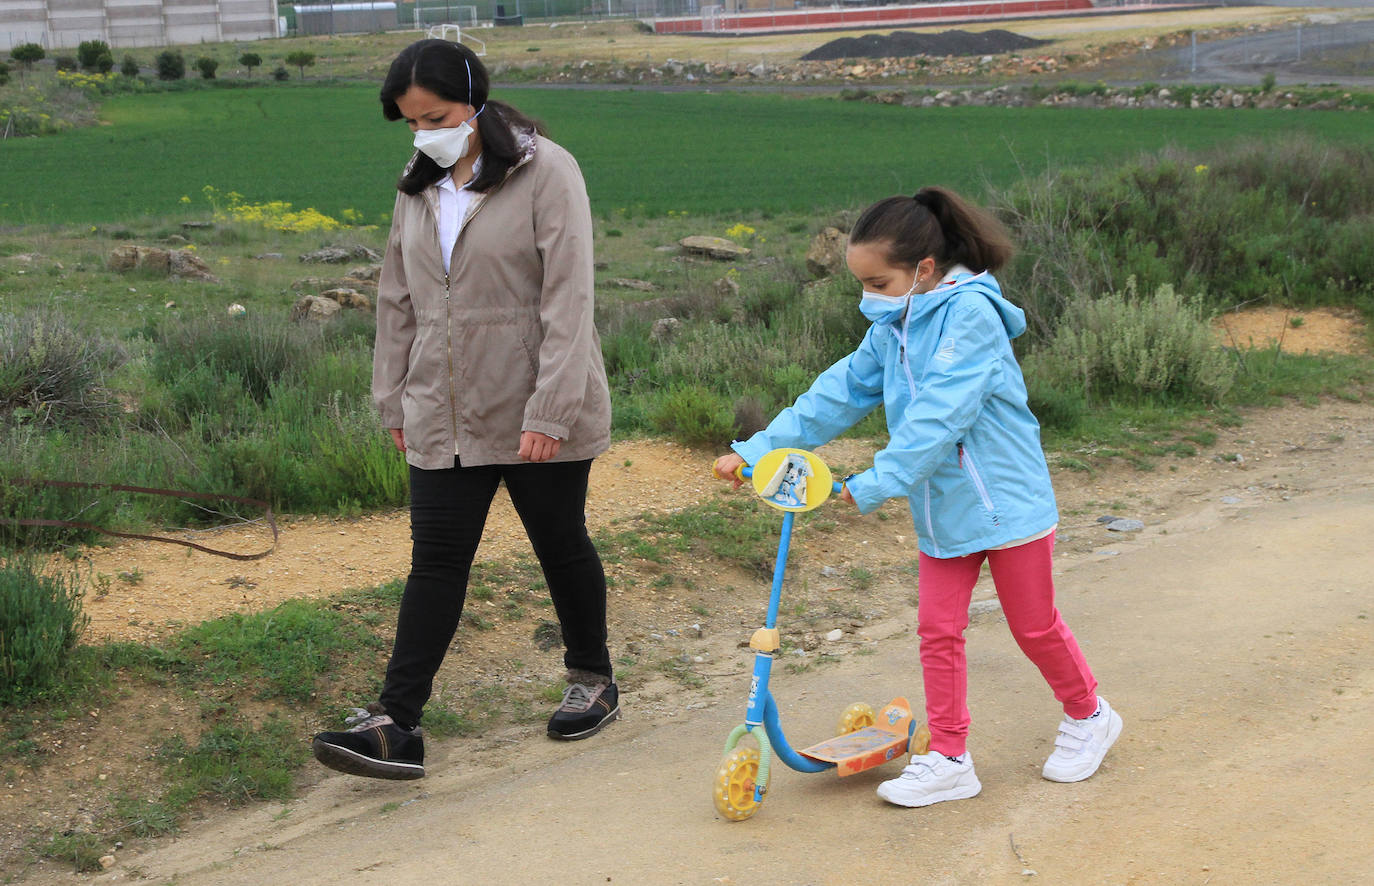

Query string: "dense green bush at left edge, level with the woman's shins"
[0, 555, 87, 705]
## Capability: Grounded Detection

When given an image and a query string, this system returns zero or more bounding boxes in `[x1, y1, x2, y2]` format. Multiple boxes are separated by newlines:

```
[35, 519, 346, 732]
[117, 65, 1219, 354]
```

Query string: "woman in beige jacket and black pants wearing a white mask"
[313, 40, 620, 779]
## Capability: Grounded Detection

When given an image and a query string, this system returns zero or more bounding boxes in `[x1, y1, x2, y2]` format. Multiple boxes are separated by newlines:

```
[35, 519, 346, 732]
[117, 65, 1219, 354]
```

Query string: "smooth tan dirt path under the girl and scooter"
[30, 402, 1374, 886]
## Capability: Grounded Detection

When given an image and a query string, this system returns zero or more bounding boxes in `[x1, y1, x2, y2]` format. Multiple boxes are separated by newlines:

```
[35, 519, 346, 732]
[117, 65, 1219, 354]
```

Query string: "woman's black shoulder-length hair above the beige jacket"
[382, 40, 545, 195]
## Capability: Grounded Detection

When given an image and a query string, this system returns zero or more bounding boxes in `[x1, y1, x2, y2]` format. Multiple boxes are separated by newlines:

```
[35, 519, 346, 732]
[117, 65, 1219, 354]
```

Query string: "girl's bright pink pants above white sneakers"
[916, 533, 1098, 757]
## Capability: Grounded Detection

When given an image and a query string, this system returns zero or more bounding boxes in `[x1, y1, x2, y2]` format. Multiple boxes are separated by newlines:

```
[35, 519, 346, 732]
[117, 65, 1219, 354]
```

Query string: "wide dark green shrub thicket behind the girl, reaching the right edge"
[996, 137, 1374, 346]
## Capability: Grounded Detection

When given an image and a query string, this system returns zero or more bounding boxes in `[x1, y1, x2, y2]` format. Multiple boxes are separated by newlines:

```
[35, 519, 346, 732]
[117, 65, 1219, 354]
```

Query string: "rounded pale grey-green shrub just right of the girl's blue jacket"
[1026, 277, 1235, 412]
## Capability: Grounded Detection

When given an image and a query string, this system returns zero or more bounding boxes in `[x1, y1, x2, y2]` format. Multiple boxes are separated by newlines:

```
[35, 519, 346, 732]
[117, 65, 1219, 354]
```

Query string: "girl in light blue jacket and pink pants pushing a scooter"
[714, 187, 1121, 806]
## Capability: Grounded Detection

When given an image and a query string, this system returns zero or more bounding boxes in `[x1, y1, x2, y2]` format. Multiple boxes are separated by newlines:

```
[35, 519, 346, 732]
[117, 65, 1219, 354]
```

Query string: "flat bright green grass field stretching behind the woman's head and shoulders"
[0, 85, 1369, 224]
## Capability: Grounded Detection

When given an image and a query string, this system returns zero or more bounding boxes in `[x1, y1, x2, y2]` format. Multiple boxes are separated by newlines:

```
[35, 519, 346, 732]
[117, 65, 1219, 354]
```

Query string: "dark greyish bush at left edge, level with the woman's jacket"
[0, 309, 125, 427]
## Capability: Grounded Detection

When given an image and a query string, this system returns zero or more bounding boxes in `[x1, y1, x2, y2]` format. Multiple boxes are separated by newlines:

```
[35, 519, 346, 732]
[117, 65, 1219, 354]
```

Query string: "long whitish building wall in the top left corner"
[0, 0, 278, 52]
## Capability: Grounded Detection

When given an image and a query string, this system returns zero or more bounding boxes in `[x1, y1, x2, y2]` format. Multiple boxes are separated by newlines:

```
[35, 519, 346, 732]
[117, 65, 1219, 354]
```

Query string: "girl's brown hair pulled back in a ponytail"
[849, 187, 1013, 272]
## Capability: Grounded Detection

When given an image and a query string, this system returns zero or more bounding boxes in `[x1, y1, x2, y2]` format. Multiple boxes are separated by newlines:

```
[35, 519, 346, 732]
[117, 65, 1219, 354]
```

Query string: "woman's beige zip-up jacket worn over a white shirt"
[372, 133, 610, 470]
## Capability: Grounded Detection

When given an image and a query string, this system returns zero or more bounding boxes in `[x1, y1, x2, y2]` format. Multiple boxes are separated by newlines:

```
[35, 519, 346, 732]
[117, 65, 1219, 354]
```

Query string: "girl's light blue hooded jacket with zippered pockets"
[734, 269, 1059, 558]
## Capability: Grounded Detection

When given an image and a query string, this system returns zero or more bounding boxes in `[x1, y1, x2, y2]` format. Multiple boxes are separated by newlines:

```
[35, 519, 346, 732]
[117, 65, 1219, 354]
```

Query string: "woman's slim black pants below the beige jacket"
[381, 460, 611, 727]
